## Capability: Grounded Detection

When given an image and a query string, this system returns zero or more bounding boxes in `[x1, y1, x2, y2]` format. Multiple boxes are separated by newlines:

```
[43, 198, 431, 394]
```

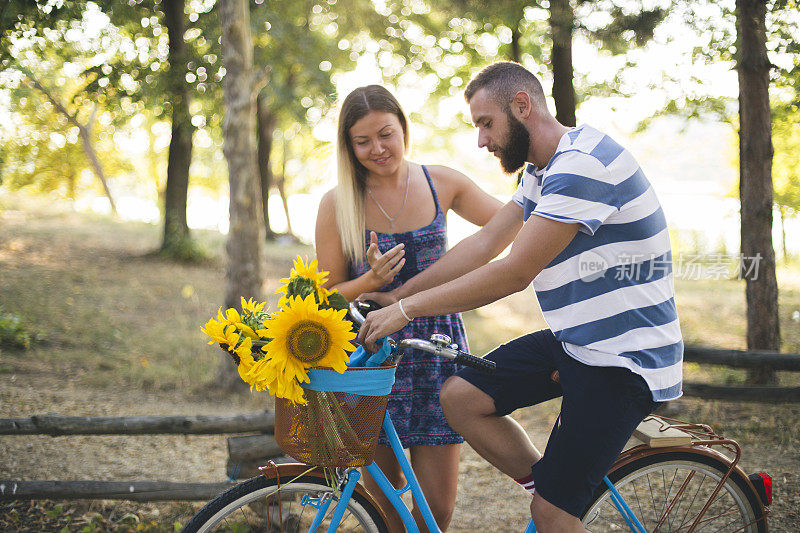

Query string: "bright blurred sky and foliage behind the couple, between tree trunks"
[0, 0, 800, 255]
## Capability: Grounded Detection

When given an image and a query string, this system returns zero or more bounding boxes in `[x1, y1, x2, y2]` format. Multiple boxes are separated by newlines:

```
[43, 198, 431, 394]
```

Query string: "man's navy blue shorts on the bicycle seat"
[456, 330, 658, 518]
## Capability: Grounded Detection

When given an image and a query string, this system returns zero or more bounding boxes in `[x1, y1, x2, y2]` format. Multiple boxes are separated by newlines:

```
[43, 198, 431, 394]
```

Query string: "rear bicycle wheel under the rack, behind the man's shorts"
[583, 449, 767, 533]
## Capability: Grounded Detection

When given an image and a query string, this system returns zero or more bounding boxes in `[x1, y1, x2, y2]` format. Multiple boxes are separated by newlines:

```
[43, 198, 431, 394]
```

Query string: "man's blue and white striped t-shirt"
[513, 125, 683, 401]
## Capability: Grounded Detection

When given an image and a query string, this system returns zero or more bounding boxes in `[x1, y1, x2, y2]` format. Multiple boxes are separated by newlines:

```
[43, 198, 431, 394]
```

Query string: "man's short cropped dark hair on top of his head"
[464, 61, 547, 111]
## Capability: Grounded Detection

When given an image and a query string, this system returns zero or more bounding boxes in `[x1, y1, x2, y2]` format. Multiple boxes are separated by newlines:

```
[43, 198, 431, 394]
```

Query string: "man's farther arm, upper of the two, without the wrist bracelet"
[363, 197, 522, 305]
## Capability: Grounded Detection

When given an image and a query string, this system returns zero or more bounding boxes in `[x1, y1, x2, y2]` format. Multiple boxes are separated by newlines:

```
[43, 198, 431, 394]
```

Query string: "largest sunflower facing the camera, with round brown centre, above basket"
[256, 294, 356, 403]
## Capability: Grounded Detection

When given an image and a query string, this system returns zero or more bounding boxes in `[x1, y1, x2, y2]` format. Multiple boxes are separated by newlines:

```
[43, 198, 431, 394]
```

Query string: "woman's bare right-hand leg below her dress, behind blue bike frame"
[411, 444, 461, 531]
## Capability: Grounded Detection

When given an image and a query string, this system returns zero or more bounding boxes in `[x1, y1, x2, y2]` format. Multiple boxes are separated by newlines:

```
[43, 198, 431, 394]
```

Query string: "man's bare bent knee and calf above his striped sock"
[439, 376, 541, 479]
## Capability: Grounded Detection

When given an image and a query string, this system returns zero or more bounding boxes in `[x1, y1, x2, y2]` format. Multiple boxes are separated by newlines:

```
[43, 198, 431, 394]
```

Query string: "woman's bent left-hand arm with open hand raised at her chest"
[314, 189, 405, 300]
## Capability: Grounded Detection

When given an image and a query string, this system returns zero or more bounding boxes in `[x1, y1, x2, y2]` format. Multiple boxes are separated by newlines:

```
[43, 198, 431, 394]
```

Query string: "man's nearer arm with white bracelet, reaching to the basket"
[358, 216, 579, 349]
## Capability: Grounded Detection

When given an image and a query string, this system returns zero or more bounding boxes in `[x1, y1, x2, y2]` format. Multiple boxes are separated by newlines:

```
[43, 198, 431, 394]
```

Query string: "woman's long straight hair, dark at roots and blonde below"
[336, 85, 408, 264]
